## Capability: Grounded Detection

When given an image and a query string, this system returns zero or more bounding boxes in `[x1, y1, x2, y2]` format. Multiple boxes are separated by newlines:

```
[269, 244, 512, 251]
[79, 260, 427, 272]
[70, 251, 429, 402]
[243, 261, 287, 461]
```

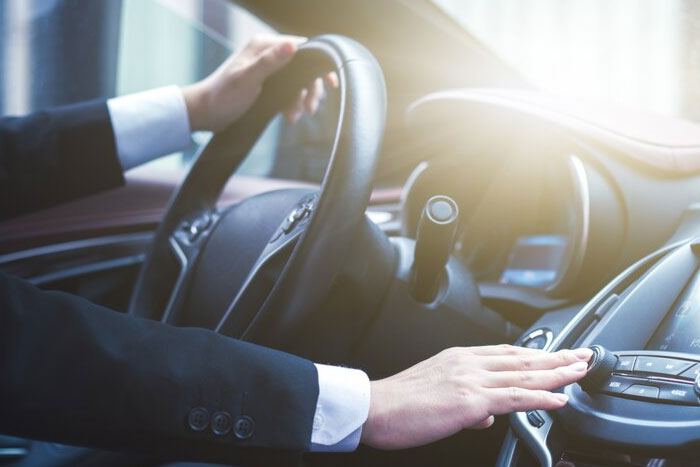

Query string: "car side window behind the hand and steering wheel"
[0, 0, 338, 182]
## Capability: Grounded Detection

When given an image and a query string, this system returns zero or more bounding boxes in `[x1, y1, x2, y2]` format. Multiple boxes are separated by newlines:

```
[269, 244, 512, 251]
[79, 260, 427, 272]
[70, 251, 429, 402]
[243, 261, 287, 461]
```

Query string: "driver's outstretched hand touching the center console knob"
[361, 345, 592, 449]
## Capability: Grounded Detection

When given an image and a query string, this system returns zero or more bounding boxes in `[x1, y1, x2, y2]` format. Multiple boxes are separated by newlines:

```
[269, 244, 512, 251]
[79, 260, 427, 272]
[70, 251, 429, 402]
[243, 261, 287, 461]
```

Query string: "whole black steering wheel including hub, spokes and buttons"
[129, 35, 386, 348]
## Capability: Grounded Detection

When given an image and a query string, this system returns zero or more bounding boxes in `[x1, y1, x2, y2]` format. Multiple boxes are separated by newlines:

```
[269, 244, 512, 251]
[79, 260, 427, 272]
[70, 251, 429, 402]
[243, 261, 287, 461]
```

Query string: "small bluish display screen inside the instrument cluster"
[500, 235, 567, 287]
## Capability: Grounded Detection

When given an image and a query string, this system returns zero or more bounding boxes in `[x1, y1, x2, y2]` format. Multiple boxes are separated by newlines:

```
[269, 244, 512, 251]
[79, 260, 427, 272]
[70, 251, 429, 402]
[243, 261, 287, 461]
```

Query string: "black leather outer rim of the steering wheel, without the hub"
[129, 35, 386, 348]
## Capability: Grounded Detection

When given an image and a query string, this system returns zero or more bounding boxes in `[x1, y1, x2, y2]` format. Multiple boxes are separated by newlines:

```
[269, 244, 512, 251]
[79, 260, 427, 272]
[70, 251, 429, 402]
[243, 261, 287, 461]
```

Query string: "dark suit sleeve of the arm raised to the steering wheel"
[0, 101, 124, 220]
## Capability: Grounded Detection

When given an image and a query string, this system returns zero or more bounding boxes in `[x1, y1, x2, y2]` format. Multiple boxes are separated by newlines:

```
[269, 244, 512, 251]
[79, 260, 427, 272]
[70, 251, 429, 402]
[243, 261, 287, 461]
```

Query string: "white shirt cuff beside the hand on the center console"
[311, 364, 370, 452]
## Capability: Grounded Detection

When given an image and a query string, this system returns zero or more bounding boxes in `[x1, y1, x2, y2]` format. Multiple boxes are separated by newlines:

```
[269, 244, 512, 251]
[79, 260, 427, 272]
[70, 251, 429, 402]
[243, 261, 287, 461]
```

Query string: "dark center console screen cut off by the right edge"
[647, 276, 700, 355]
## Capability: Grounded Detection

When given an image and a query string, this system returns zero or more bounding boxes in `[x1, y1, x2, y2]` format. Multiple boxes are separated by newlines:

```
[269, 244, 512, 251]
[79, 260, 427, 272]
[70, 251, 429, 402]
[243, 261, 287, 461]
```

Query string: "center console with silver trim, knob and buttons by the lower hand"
[499, 239, 700, 466]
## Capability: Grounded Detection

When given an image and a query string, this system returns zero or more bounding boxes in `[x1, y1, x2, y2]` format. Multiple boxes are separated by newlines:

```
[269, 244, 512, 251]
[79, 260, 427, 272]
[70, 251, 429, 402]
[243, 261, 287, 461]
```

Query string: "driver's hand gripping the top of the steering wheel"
[182, 35, 338, 131]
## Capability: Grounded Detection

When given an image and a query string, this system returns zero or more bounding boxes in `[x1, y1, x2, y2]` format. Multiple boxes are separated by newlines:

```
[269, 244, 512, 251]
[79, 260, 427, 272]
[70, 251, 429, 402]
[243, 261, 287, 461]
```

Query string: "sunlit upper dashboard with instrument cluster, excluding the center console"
[402, 89, 700, 309]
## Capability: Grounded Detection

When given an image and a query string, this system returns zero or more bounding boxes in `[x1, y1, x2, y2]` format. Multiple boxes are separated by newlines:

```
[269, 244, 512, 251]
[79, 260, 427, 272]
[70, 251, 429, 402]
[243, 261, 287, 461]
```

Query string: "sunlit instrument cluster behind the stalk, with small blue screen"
[404, 154, 589, 292]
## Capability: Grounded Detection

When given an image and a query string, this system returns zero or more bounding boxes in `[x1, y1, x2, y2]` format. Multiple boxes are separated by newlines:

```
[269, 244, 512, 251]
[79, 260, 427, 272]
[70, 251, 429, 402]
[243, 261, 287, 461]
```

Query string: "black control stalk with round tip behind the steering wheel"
[409, 196, 459, 303]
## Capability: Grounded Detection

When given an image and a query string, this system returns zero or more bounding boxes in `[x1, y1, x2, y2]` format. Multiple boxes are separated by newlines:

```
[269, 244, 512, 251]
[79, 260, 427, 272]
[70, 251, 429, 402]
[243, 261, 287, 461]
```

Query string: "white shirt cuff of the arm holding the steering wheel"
[107, 86, 191, 170]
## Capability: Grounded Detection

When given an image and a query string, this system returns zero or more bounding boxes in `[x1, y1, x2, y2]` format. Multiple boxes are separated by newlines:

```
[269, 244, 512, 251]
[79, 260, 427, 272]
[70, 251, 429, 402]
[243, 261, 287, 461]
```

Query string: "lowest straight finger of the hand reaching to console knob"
[488, 387, 569, 415]
